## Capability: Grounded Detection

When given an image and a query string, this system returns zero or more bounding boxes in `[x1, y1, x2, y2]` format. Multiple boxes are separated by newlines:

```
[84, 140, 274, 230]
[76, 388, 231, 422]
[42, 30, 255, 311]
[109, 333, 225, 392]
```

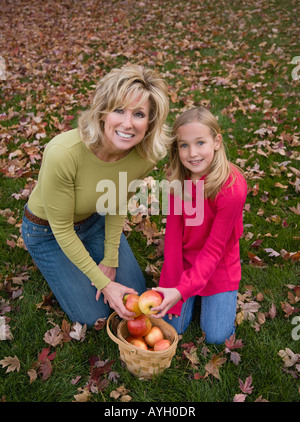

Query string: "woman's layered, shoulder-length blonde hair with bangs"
[78, 64, 170, 163]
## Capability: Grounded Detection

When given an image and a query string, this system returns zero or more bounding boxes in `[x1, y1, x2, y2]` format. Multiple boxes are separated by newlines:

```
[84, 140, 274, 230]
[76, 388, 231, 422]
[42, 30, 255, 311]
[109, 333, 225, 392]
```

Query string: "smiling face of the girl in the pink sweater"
[177, 121, 222, 181]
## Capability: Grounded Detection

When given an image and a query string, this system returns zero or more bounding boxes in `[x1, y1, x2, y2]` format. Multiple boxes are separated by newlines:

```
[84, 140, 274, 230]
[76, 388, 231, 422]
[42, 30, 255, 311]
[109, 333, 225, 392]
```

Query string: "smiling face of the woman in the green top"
[103, 98, 150, 157]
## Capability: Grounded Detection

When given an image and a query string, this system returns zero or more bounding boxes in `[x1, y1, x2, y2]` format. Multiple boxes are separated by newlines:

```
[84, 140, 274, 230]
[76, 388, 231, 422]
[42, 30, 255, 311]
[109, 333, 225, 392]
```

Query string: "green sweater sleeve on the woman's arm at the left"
[41, 145, 110, 290]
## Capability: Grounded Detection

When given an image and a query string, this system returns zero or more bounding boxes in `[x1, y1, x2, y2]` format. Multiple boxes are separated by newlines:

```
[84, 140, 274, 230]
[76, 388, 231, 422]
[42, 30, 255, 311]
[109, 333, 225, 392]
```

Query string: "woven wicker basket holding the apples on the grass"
[106, 312, 178, 378]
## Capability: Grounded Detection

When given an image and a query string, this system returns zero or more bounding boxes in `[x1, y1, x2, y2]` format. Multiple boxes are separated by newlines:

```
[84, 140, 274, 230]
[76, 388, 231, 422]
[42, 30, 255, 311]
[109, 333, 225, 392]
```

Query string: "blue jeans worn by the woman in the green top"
[22, 208, 146, 326]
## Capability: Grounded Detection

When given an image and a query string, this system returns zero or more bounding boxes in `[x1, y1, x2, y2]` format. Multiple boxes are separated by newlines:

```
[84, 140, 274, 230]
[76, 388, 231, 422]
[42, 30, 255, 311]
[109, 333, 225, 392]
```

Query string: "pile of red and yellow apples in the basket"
[123, 290, 171, 352]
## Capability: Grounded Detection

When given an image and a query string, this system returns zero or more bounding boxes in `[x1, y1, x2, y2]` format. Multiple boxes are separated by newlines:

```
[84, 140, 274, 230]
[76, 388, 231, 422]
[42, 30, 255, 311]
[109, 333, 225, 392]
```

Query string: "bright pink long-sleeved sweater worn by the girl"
[159, 169, 247, 315]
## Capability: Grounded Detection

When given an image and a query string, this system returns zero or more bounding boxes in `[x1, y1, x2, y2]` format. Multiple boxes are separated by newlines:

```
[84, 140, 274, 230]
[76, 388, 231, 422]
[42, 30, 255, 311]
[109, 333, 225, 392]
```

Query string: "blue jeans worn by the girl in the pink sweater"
[164, 290, 237, 344]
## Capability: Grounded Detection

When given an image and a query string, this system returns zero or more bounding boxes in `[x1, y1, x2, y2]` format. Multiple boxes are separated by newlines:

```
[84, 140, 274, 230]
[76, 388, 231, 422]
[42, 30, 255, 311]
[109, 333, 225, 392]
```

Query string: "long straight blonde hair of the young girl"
[168, 107, 237, 199]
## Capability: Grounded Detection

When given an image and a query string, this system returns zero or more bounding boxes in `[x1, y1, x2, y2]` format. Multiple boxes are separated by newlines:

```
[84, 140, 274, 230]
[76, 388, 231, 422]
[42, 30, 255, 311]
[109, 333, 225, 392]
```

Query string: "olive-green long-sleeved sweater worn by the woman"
[28, 129, 154, 290]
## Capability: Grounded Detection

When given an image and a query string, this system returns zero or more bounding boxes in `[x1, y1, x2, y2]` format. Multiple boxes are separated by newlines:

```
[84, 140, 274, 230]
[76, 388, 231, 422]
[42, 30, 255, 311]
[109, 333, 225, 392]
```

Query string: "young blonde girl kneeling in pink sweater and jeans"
[153, 107, 247, 344]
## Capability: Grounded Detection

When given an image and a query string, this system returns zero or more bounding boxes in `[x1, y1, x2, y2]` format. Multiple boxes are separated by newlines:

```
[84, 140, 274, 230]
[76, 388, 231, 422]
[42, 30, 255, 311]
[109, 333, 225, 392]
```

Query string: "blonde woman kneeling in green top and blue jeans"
[22, 65, 169, 326]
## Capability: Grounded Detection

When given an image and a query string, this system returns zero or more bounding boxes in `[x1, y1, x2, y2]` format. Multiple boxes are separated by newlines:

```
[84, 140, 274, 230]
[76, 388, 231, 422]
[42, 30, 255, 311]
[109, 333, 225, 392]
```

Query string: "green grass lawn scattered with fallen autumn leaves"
[0, 0, 300, 406]
